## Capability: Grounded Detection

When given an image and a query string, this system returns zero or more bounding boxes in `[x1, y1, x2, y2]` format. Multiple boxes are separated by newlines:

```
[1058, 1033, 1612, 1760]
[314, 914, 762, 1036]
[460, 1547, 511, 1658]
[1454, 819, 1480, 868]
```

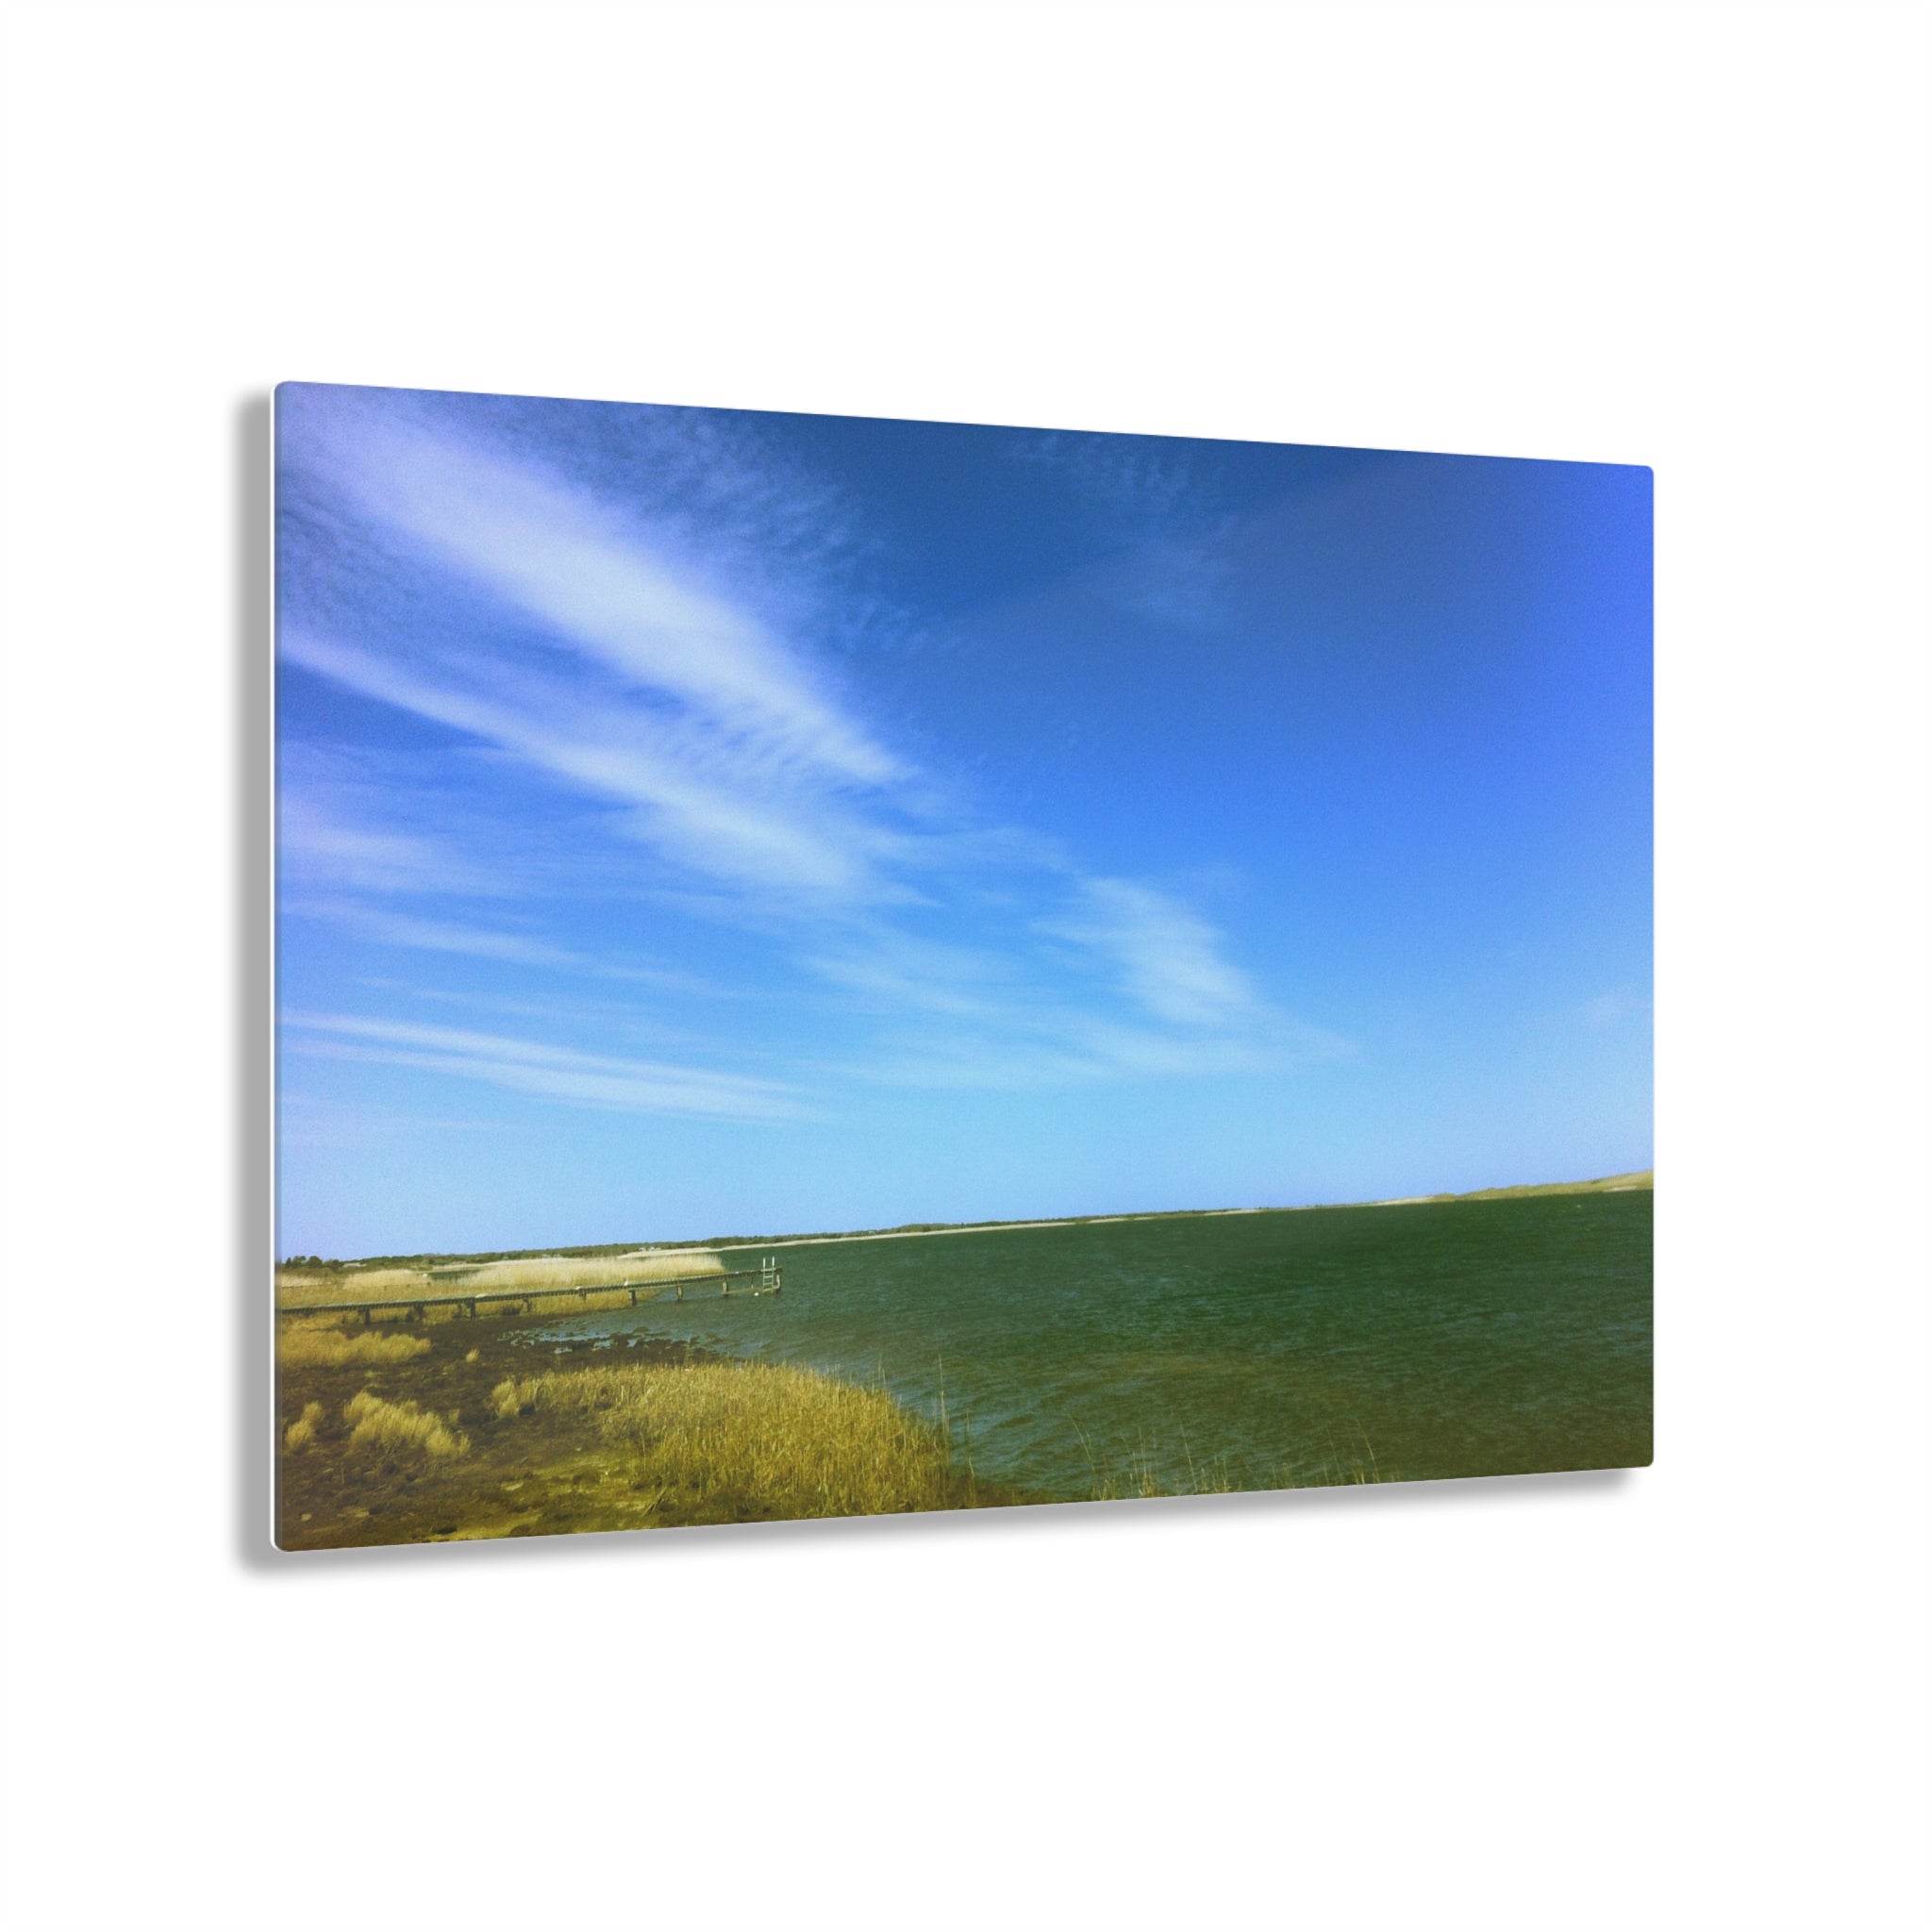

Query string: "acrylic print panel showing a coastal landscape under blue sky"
[276, 385, 1652, 1547]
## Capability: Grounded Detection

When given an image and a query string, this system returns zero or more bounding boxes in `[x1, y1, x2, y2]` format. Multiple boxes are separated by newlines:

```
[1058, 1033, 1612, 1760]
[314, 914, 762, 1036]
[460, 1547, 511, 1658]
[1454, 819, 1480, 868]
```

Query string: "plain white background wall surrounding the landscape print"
[0, 0, 1932, 1932]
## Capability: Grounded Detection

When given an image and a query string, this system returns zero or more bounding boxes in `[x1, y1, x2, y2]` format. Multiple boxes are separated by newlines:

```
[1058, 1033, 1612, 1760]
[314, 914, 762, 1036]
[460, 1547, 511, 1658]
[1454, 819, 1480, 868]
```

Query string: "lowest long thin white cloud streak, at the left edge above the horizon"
[282, 1012, 806, 1121]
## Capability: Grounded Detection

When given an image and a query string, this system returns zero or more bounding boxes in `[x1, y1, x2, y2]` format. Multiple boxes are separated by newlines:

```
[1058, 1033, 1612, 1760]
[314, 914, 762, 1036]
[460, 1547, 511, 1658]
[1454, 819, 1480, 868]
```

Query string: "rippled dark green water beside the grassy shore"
[545, 1191, 1652, 1497]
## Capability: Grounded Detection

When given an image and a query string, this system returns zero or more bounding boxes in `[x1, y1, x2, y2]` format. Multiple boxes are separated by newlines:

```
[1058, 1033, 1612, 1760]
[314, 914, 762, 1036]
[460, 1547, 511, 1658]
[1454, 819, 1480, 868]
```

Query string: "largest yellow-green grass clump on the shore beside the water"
[496, 1362, 958, 1517]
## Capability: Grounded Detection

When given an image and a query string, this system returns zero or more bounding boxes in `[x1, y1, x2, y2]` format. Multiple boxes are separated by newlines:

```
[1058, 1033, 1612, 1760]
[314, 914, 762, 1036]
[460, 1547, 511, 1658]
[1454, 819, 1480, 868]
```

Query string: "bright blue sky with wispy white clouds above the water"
[276, 385, 1650, 1256]
